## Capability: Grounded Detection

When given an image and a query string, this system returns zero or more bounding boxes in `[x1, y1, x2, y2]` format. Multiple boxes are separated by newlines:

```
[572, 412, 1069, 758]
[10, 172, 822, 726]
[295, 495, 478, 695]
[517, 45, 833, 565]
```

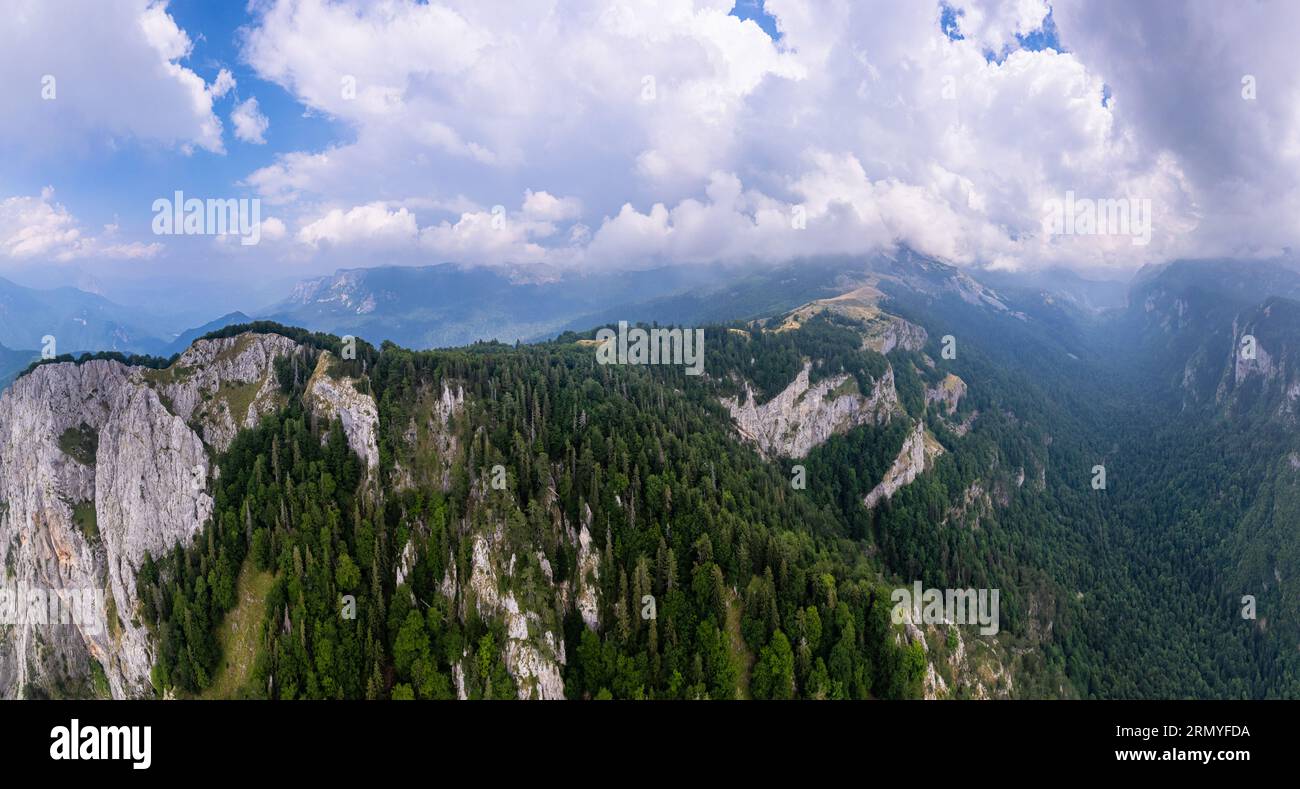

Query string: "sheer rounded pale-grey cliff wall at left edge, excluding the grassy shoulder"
[0, 361, 212, 698]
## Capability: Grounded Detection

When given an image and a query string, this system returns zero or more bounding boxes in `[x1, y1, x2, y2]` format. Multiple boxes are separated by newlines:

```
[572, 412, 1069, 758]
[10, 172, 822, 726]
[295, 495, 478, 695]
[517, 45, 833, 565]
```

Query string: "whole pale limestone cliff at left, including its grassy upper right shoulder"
[0, 334, 351, 698]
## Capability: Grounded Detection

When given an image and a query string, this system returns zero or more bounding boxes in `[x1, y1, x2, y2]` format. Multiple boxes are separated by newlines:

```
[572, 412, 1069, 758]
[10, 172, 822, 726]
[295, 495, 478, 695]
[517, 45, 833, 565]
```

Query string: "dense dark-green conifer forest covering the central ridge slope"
[138, 323, 924, 698]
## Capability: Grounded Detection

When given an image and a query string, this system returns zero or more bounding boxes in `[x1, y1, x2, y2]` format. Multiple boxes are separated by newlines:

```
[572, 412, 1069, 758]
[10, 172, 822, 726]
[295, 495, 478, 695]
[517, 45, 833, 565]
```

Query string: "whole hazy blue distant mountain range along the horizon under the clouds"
[0, 257, 1122, 366]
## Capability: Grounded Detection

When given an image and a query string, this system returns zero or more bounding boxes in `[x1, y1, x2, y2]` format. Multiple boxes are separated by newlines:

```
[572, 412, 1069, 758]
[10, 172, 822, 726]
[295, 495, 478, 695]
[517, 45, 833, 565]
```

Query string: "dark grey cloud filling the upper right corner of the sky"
[1056, 0, 1300, 256]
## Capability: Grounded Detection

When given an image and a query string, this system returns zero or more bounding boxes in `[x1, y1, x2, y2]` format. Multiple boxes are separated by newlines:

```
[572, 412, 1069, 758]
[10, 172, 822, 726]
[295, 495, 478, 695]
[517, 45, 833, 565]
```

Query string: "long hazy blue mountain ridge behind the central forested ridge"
[259, 264, 857, 348]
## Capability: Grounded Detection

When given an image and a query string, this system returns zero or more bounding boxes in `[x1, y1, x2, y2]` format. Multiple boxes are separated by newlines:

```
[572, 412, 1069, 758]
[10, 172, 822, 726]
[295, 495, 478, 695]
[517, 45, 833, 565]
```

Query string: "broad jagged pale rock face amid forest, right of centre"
[722, 361, 901, 458]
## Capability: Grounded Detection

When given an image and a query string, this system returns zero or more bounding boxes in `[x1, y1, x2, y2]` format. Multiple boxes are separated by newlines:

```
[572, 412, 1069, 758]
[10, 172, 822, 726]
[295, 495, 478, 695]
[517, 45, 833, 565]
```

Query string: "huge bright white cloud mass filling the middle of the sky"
[228, 0, 1196, 276]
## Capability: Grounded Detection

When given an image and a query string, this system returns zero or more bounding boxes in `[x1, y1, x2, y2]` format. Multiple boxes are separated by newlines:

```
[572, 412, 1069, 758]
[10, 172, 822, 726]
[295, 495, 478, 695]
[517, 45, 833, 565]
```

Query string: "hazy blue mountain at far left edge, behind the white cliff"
[0, 279, 165, 354]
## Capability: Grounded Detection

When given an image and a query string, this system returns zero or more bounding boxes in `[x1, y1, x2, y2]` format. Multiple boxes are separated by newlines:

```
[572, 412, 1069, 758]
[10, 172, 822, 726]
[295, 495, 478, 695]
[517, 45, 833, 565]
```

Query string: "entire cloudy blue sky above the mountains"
[0, 0, 1300, 318]
